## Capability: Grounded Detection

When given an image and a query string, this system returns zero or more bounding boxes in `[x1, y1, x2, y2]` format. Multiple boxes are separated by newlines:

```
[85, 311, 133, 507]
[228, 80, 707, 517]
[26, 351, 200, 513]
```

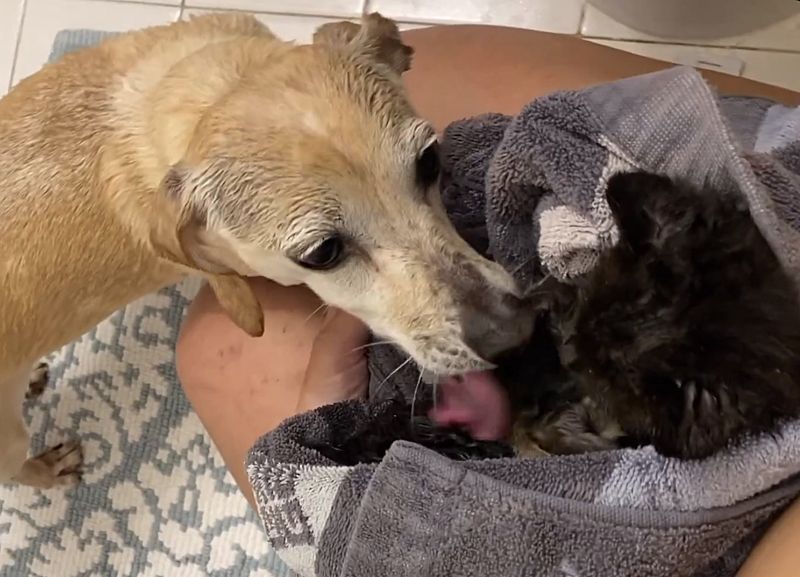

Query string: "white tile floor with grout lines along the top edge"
[0, 0, 800, 94]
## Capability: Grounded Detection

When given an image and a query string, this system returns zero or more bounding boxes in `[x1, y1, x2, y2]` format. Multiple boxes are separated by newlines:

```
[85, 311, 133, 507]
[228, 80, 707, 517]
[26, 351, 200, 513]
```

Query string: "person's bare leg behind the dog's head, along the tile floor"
[403, 25, 800, 130]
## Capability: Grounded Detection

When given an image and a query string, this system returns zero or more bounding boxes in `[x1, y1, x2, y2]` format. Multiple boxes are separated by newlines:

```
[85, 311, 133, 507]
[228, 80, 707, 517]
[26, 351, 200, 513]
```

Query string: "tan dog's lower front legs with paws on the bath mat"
[0, 364, 83, 489]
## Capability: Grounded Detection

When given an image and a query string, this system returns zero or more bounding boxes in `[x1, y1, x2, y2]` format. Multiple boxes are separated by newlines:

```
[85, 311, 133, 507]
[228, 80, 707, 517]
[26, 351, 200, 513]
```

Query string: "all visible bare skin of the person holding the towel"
[177, 26, 800, 577]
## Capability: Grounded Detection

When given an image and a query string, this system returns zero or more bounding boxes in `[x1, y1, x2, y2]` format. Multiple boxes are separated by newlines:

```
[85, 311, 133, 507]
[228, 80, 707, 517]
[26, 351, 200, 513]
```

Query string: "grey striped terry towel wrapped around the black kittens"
[248, 68, 800, 577]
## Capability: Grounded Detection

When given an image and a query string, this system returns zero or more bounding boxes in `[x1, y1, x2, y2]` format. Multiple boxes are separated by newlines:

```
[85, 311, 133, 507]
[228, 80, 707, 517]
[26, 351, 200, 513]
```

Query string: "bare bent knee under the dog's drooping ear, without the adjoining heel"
[176, 281, 322, 502]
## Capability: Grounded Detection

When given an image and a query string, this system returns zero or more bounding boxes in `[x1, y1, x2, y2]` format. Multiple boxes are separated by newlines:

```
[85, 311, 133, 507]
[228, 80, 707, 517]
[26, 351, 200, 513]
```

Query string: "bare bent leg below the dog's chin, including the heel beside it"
[176, 280, 368, 504]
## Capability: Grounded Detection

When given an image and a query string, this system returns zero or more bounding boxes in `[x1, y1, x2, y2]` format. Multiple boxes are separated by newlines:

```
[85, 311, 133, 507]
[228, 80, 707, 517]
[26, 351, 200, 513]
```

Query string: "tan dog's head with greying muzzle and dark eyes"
[165, 14, 532, 374]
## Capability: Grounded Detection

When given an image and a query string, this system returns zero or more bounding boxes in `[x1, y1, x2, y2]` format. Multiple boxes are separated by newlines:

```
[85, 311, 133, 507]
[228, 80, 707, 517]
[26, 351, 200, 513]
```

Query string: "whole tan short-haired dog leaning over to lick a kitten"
[0, 14, 531, 487]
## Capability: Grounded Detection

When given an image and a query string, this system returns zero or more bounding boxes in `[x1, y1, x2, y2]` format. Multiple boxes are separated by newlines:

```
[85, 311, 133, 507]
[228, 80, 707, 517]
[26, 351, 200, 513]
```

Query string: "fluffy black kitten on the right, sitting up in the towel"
[536, 173, 800, 458]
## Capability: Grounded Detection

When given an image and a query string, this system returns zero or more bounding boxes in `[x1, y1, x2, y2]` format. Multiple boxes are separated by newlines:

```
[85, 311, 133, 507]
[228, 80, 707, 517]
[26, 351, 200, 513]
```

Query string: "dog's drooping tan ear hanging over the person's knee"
[161, 166, 264, 337]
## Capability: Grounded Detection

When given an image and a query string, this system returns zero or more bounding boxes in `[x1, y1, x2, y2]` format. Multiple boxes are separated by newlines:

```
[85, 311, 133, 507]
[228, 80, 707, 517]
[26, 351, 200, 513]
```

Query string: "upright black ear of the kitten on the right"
[606, 172, 672, 251]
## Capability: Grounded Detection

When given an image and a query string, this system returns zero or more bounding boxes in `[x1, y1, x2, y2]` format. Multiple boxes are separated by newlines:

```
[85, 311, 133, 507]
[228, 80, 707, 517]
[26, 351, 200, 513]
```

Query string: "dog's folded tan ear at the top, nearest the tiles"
[314, 12, 414, 74]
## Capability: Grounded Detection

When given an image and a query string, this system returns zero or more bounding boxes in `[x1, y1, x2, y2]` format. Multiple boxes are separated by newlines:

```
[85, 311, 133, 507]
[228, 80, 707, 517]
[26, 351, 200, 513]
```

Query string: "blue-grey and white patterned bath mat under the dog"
[0, 31, 291, 577]
